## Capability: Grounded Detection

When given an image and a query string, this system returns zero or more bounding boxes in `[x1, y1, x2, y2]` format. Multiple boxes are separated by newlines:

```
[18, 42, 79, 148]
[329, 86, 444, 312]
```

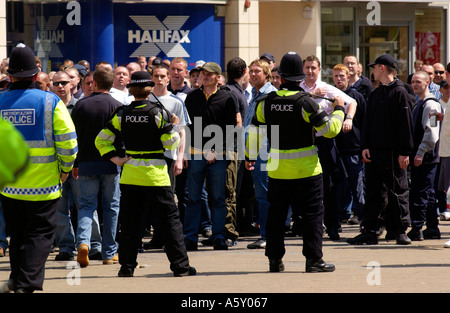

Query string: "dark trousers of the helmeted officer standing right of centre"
[265, 174, 324, 259]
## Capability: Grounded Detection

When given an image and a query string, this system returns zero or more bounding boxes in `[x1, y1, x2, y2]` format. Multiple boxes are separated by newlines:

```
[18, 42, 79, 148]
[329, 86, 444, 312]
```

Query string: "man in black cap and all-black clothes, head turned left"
[347, 54, 413, 245]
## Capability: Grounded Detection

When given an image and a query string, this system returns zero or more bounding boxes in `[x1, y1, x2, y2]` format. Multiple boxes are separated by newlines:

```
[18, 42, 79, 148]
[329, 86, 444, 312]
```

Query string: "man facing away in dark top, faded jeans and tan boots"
[72, 69, 122, 267]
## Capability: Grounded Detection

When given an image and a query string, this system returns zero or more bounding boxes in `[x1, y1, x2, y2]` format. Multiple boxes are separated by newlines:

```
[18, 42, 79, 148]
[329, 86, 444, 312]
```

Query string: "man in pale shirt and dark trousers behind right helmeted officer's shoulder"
[300, 55, 357, 240]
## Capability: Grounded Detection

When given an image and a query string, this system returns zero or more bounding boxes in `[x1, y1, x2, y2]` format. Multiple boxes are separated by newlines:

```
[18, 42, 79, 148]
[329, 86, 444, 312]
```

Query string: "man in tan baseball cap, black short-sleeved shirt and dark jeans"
[184, 62, 242, 250]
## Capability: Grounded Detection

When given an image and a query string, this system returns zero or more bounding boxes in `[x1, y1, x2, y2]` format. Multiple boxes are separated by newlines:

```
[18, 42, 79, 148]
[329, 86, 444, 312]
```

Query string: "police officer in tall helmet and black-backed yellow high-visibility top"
[246, 52, 344, 272]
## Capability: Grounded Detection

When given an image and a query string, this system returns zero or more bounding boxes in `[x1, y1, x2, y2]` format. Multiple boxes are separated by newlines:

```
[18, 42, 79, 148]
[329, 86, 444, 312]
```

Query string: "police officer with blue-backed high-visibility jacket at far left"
[0, 44, 78, 292]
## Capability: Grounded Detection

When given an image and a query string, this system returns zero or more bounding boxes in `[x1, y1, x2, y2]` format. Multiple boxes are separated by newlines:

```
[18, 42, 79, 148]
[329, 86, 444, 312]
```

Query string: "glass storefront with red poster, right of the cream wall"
[320, 2, 448, 83]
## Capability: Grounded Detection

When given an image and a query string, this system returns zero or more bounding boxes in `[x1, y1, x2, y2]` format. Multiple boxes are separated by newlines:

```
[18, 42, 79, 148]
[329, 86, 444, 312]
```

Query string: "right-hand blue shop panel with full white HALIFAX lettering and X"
[114, 3, 224, 68]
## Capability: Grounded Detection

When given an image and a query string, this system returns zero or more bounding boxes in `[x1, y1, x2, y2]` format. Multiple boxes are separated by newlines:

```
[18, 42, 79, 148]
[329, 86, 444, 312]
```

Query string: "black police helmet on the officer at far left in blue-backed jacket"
[7, 43, 39, 78]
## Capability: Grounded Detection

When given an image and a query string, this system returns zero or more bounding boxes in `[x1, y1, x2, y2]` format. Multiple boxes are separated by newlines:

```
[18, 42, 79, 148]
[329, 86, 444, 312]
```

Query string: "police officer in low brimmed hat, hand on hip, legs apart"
[95, 71, 196, 277]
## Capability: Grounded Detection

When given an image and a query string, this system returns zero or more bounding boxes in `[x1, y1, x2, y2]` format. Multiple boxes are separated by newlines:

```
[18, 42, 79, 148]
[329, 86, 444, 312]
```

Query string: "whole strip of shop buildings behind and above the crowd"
[0, 0, 450, 80]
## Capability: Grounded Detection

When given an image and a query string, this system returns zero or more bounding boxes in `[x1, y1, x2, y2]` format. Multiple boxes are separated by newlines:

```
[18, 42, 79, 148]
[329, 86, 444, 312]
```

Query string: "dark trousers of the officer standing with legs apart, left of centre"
[118, 184, 189, 272]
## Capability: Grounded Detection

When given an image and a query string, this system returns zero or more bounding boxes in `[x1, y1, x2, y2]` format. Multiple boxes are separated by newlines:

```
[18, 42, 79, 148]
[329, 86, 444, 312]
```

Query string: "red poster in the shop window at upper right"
[416, 32, 441, 65]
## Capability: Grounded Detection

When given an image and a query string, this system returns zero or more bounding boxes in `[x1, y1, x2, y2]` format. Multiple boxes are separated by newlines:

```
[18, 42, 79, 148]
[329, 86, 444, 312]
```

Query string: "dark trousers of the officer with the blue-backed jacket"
[1, 196, 57, 292]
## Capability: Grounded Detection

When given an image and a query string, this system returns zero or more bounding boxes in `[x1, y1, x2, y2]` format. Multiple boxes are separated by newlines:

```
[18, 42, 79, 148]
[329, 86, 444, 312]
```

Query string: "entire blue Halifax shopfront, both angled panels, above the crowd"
[30, 0, 224, 71]
